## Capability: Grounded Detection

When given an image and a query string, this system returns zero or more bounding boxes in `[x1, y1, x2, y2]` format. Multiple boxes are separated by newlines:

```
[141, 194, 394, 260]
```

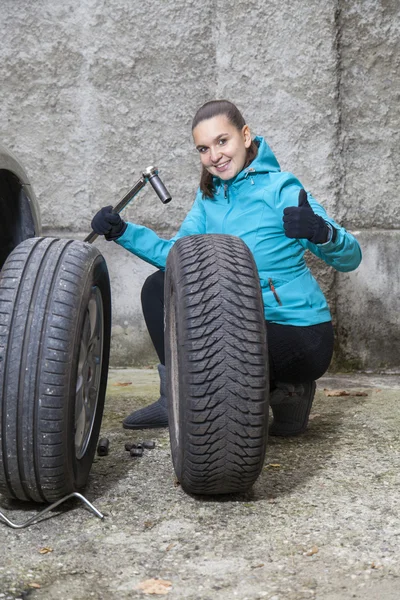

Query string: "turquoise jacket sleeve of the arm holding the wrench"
[116, 193, 206, 270]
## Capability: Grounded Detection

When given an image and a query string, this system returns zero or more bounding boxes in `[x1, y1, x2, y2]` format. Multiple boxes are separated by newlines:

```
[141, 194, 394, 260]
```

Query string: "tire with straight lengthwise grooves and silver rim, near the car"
[0, 238, 111, 502]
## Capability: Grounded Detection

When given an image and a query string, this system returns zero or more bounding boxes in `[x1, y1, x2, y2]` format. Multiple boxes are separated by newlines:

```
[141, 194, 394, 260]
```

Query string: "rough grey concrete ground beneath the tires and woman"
[0, 369, 400, 600]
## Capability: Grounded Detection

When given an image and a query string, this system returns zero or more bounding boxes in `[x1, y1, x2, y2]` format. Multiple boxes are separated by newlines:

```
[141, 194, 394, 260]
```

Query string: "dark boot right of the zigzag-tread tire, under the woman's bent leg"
[269, 381, 316, 437]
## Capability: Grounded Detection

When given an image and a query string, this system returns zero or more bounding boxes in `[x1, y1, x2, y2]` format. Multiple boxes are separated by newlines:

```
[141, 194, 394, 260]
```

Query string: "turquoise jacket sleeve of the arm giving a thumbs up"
[278, 178, 362, 272]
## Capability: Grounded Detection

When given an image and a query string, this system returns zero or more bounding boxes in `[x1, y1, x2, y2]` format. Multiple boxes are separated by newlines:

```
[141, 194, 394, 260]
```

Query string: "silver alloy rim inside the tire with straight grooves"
[75, 286, 104, 460]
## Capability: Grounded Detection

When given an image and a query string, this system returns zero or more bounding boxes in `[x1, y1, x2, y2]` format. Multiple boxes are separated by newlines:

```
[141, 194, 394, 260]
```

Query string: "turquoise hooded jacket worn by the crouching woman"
[117, 137, 361, 325]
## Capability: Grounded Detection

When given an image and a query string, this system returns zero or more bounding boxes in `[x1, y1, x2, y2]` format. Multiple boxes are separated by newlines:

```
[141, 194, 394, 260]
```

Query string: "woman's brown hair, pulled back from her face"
[192, 100, 258, 198]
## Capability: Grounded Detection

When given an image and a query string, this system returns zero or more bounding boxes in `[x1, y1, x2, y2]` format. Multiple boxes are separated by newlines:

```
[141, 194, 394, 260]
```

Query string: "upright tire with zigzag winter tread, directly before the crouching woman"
[165, 234, 269, 495]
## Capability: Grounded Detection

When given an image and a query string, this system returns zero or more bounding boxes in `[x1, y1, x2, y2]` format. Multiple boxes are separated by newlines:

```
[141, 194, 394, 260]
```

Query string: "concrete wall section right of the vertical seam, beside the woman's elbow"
[336, 0, 400, 370]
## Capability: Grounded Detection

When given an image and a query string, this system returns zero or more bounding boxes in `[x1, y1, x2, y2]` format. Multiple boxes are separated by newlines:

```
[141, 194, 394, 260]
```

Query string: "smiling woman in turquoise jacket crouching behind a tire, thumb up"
[92, 100, 361, 436]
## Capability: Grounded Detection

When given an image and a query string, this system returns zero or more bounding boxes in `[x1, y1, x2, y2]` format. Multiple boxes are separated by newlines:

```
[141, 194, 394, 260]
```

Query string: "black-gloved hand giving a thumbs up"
[283, 190, 333, 244]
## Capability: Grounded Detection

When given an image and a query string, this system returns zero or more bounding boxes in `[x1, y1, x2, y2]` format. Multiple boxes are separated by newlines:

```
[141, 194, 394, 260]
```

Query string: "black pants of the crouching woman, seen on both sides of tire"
[141, 271, 333, 387]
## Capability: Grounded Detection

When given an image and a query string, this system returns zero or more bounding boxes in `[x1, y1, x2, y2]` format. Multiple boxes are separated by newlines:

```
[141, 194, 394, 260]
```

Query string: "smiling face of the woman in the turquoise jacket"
[193, 115, 251, 180]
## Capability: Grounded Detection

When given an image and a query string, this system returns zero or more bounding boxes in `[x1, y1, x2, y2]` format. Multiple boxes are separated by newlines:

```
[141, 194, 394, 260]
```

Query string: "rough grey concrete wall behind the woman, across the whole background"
[0, 0, 400, 369]
